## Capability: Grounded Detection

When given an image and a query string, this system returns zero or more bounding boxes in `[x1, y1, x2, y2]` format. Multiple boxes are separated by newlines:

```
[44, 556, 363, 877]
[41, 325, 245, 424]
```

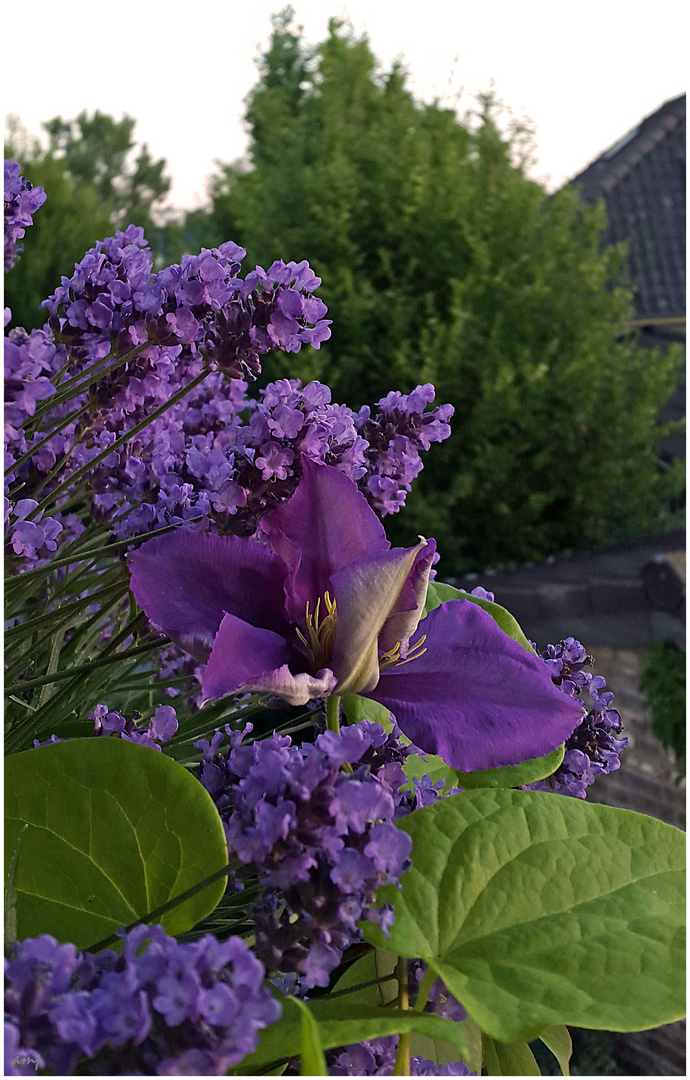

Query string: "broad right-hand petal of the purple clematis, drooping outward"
[367, 600, 582, 772]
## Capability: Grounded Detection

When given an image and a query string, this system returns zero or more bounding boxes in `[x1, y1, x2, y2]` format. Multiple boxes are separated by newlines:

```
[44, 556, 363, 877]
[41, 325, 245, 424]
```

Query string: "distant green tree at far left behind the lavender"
[5, 110, 171, 329]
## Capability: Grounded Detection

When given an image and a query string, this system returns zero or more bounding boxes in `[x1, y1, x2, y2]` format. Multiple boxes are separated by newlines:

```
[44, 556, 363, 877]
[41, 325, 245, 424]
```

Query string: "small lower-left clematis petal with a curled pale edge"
[202, 613, 336, 705]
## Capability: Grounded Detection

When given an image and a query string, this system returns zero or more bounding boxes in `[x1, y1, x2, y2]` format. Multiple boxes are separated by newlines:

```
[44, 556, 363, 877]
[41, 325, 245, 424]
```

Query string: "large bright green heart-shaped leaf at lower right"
[363, 788, 685, 1042]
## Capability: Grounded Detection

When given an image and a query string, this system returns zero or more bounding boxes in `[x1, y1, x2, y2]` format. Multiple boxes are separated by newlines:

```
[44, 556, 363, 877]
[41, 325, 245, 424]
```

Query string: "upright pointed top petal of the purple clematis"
[259, 457, 390, 625]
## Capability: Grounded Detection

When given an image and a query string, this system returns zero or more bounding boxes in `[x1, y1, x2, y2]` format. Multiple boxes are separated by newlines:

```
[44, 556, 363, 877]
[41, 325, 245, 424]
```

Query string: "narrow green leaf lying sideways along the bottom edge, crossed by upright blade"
[235, 997, 468, 1076]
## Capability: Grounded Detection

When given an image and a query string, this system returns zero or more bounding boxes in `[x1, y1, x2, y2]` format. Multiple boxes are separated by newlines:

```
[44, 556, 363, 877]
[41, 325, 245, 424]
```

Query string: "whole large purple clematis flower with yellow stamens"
[130, 459, 582, 771]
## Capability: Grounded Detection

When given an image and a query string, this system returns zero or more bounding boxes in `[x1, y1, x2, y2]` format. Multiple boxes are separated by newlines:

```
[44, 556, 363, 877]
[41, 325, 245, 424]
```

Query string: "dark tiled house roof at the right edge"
[570, 94, 686, 319]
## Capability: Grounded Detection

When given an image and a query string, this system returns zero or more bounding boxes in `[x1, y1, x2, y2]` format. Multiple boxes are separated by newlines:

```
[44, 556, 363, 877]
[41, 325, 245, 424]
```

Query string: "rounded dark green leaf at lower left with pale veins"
[4, 738, 228, 948]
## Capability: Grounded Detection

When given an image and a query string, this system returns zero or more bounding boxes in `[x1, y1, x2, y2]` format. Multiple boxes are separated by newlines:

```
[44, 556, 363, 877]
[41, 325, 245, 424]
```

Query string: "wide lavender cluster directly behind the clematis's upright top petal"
[97, 376, 451, 538]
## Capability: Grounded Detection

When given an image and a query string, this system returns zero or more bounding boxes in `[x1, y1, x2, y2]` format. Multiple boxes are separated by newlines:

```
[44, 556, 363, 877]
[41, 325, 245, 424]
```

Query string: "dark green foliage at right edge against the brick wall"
[639, 642, 686, 775]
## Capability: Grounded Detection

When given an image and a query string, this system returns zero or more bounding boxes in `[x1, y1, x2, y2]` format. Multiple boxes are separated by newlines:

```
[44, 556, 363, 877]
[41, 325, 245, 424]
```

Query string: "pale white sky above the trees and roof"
[2, 0, 688, 207]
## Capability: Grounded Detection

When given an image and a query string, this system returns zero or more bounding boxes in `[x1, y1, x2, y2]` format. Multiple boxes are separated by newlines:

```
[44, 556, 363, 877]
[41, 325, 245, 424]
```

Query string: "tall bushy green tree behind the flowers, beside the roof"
[188, 9, 682, 573]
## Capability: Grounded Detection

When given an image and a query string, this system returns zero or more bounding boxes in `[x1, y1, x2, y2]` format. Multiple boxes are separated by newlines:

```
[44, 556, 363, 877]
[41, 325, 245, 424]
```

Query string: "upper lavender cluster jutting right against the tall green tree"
[43, 225, 330, 388]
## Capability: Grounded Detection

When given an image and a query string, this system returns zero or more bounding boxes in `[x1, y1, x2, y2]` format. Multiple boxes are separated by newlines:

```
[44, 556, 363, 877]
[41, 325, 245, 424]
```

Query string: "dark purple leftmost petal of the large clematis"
[127, 531, 287, 660]
